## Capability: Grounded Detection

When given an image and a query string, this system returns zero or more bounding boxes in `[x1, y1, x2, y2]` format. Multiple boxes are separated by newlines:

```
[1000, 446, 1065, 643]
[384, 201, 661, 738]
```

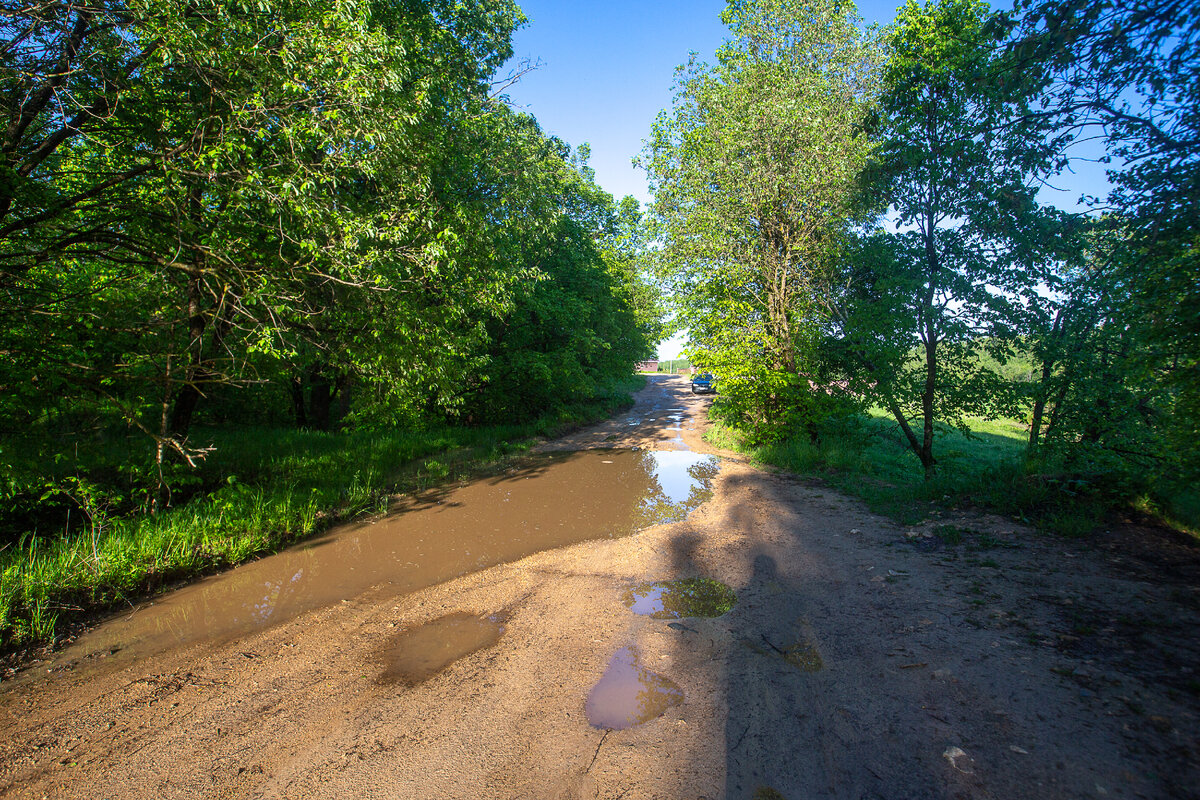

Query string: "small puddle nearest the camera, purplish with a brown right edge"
[584, 648, 683, 730]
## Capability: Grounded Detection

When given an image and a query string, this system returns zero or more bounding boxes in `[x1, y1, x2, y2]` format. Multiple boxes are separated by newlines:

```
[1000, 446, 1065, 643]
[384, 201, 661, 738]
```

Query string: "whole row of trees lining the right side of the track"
[643, 0, 1200, 525]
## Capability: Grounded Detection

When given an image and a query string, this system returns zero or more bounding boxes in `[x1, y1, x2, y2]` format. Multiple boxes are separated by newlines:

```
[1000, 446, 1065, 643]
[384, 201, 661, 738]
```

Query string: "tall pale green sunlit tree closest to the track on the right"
[643, 0, 878, 437]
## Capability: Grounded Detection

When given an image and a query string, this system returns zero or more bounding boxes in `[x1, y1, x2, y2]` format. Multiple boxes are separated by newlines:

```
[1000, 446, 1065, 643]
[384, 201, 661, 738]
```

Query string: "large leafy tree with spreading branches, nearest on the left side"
[0, 0, 522, 453]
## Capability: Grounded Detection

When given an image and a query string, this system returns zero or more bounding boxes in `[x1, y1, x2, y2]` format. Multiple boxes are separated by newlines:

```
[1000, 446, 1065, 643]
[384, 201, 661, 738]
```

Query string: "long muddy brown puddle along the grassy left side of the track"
[49, 450, 720, 661]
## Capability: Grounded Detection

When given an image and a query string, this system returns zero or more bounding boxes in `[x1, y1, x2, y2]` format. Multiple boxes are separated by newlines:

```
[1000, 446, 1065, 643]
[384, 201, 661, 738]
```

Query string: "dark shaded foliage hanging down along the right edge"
[997, 0, 1200, 493]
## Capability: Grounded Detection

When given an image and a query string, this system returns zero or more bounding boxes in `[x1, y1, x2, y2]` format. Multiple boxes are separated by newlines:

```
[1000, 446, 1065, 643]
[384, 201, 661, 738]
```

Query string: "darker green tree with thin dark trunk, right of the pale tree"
[839, 0, 1063, 477]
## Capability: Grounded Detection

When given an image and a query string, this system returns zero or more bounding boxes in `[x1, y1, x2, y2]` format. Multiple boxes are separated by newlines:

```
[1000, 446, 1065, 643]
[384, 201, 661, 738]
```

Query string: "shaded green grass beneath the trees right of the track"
[706, 414, 1108, 536]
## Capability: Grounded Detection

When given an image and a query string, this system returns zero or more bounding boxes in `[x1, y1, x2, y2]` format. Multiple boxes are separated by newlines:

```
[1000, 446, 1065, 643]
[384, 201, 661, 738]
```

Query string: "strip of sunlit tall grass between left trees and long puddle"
[0, 377, 646, 649]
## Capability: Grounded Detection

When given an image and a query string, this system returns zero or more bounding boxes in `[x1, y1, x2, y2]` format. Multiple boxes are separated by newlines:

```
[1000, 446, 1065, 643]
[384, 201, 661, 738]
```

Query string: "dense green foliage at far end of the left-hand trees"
[453, 142, 658, 421]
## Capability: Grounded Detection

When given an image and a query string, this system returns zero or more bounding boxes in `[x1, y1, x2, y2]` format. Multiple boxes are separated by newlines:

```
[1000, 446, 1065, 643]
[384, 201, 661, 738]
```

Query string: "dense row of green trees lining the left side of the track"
[0, 0, 656, 527]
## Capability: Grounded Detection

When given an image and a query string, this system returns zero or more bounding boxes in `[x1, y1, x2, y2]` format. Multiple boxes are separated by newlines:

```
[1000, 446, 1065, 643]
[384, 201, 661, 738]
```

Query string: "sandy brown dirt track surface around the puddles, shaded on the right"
[0, 378, 1200, 800]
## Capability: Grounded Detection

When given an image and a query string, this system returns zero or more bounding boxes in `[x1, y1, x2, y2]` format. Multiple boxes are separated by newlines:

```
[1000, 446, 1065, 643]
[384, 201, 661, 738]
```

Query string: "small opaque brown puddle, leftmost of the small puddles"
[379, 612, 504, 686]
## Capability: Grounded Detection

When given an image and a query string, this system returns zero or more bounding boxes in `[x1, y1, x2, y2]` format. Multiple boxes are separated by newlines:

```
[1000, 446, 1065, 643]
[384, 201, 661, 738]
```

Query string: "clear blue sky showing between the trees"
[496, 0, 1106, 359]
